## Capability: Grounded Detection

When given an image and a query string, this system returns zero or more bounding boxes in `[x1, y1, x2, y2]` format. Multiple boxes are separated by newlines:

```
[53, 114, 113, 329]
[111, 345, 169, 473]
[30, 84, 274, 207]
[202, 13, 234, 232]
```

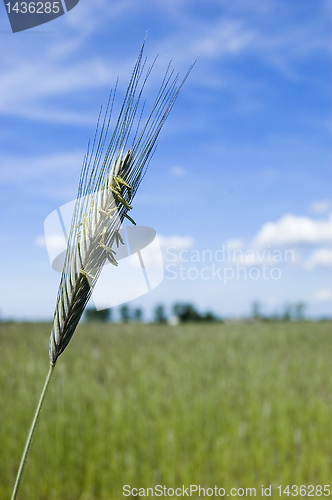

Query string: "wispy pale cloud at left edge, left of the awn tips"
[0, 55, 117, 124]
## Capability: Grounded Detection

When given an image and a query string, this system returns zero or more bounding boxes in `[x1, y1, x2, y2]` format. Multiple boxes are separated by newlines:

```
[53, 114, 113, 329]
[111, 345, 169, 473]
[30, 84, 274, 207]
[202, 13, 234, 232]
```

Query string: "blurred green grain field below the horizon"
[0, 322, 332, 500]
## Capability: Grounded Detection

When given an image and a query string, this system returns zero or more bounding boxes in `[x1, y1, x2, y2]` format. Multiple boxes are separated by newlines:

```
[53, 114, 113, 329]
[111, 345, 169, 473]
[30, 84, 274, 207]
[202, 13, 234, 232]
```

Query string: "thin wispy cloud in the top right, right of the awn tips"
[159, 2, 330, 85]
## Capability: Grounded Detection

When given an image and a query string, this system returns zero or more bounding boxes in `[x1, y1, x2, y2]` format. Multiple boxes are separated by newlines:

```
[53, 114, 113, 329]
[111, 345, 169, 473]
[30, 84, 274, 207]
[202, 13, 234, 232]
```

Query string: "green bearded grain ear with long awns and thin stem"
[11, 44, 194, 500]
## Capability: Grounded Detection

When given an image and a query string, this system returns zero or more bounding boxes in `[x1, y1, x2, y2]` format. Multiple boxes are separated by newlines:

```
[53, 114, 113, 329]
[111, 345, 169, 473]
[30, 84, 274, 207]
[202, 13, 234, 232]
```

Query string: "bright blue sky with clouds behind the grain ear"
[0, 0, 332, 320]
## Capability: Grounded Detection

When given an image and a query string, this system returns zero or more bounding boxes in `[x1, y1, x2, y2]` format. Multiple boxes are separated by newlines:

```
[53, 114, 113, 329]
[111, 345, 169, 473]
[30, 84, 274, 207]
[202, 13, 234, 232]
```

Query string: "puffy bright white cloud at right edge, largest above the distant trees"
[254, 213, 332, 246]
